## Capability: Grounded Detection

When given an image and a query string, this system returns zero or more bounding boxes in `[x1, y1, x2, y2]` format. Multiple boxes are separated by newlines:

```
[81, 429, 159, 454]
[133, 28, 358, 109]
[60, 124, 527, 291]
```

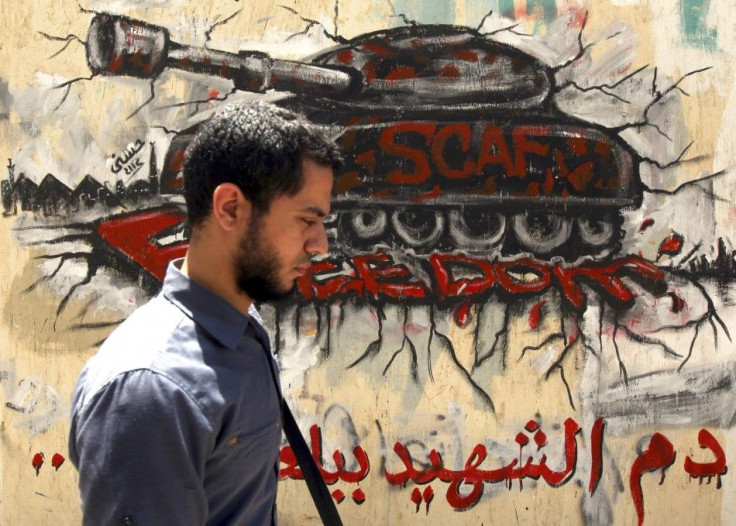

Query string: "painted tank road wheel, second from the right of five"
[512, 213, 572, 254]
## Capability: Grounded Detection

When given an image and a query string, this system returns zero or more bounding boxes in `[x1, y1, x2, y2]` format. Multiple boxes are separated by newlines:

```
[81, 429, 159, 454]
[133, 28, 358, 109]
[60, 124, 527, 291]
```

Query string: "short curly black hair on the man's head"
[184, 102, 342, 227]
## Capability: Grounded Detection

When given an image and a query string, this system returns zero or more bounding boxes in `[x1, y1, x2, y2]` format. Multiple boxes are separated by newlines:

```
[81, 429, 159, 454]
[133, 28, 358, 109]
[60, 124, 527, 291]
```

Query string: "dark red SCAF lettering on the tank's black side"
[344, 121, 628, 202]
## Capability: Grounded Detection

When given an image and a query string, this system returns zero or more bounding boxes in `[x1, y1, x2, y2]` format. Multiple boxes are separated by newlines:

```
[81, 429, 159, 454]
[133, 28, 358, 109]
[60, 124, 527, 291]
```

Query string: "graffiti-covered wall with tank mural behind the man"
[0, 0, 736, 524]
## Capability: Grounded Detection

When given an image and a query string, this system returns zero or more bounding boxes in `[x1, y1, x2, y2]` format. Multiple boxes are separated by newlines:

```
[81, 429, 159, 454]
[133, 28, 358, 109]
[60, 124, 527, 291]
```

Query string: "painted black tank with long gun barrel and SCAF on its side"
[87, 14, 642, 260]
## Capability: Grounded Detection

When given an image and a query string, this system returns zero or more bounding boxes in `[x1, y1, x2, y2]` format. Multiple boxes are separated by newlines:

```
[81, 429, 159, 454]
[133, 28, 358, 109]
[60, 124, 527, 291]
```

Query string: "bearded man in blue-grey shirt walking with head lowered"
[69, 103, 341, 525]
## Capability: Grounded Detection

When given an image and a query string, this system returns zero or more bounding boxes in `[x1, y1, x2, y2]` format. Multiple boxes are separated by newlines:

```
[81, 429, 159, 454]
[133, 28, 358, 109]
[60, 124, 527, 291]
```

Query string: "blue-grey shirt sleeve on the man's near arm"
[70, 370, 214, 525]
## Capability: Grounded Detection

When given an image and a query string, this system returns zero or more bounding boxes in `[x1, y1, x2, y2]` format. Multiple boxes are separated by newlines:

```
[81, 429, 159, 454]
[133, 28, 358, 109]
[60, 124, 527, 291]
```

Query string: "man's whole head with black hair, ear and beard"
[184, 103, 341, 301]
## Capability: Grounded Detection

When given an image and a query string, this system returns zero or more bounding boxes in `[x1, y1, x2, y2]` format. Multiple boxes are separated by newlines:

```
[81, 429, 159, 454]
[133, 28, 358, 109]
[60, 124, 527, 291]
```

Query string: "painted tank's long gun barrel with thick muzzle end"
[87, 13, 361, 96]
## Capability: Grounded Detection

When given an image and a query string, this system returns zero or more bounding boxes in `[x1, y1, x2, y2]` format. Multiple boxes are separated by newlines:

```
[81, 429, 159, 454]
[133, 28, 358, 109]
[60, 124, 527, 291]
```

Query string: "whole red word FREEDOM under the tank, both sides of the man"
[97, 208, 664, 312]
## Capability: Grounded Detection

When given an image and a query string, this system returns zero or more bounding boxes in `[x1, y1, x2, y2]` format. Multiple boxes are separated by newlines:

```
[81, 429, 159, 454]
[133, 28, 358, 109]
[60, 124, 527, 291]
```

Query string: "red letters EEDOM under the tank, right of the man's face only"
[297, 252, 664, 310]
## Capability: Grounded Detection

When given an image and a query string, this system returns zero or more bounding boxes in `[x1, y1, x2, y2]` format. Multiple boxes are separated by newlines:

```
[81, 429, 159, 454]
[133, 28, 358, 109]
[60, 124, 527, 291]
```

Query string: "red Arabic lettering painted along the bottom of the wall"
[274, 418, 727, 516]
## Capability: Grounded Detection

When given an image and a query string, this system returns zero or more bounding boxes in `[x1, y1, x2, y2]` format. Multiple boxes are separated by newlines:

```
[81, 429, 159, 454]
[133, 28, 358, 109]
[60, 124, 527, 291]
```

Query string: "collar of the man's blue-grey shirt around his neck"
[162, 258, 254, 350]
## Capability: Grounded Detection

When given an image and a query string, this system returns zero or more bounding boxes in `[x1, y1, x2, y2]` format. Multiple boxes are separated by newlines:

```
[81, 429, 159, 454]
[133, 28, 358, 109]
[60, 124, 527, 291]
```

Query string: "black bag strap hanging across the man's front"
[251, 321, 342, 526]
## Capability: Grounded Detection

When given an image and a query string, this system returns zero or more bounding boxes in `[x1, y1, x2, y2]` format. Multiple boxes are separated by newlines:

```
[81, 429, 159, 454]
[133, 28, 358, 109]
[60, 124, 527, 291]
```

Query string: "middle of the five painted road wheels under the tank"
[449, 208, 506, 250]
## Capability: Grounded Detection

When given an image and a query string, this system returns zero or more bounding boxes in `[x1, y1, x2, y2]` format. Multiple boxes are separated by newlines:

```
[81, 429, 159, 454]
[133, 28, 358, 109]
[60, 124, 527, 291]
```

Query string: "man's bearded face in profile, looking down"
[234, 159, 333, 301]
